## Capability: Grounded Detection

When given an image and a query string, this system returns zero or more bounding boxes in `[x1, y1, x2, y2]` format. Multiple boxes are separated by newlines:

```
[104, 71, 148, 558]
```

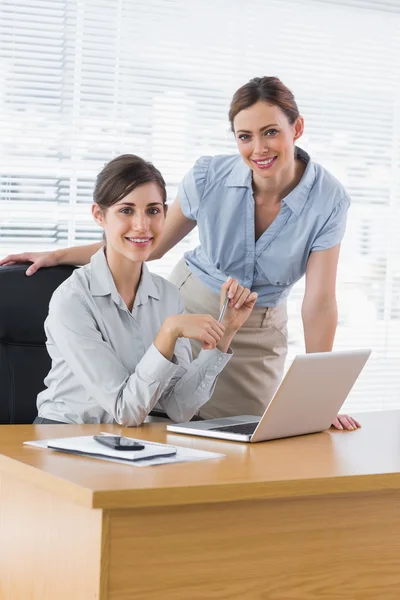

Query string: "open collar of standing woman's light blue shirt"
[225, 146, 315, 216]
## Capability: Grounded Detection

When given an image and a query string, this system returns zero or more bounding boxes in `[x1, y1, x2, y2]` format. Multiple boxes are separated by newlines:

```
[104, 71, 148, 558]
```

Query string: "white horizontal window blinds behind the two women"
[0, 0, 400, 410]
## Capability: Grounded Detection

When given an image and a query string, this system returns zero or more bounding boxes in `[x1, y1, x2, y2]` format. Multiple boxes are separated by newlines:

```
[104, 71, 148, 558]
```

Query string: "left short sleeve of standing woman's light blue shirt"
[178, 156, 211, 221]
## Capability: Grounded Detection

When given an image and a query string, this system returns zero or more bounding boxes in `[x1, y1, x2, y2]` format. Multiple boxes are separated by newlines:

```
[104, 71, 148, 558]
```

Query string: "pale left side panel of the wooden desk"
[0, 473, 106, 600]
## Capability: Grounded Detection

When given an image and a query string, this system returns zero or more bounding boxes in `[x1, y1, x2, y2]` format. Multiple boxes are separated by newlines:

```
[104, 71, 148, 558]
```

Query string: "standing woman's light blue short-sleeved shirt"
[178, 147, 350, 306]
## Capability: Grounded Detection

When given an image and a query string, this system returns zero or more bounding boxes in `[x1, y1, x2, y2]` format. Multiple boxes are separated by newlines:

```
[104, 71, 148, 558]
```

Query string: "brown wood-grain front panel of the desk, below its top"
[108, 492, 400, 600]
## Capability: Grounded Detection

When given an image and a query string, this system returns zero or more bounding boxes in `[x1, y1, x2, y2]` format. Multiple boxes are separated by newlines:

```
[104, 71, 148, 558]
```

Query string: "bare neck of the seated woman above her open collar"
[106, 248, 143, 310]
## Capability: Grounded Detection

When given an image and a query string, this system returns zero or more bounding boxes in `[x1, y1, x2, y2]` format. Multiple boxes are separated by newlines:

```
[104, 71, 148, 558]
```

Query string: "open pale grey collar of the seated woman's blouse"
[90, 248, 160, 309]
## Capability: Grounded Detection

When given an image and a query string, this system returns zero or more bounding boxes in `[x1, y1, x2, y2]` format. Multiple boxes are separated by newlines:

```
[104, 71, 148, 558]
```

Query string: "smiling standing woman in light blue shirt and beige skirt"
[0, 77, 359, 429]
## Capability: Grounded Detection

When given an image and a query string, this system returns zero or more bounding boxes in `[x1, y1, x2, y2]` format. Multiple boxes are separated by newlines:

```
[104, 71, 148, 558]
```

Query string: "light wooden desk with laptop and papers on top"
[0, 411, 400, 600]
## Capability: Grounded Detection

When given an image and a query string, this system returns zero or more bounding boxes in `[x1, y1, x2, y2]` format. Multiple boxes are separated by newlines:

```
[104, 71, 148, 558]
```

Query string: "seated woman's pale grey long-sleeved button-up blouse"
[37, 249, 230, 426]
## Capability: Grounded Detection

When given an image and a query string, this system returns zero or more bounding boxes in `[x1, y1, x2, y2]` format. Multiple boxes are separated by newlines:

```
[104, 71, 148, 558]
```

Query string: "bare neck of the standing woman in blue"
[253, 158, 304, 203]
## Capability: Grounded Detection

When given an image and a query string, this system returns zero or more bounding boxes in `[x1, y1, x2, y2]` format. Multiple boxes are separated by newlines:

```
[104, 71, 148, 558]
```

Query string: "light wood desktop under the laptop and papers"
[0, 411, 400, 508]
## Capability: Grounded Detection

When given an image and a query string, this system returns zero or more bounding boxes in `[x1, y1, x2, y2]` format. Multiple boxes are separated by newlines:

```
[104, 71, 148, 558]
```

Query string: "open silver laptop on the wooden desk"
[167, 350, 371, 443]
